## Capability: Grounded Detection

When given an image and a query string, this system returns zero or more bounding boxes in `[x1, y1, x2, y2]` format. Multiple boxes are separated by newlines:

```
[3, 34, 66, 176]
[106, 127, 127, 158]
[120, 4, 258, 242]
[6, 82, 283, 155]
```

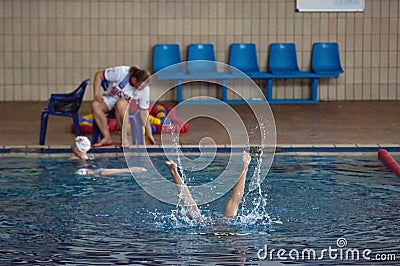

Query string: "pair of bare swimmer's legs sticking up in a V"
[165, 151, 251, 220]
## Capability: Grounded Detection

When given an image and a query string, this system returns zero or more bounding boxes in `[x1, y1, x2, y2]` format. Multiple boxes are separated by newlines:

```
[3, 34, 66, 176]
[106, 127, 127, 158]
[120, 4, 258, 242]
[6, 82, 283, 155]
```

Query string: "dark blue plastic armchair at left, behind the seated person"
[39, 79, 90, 145]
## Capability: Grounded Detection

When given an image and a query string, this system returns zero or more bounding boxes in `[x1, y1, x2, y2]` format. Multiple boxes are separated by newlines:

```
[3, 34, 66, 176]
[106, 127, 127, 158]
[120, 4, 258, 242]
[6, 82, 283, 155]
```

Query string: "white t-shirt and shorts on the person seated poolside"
[103, 66, 150, 110]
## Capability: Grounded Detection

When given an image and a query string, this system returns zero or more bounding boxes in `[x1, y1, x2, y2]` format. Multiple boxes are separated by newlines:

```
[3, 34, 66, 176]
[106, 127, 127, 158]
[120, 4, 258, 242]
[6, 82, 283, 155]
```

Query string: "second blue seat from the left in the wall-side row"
[187, 43, 217, 75]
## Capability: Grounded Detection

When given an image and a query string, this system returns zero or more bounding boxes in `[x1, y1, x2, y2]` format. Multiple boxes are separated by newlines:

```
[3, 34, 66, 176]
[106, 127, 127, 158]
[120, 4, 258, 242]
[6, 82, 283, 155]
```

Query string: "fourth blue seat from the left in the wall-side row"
[268, 43, 300, 74]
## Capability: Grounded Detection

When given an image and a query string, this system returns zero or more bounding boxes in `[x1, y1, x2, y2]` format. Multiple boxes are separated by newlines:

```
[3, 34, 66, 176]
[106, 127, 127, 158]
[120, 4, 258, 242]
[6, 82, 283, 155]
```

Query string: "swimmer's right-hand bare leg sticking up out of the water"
[224, 152, 251, 217]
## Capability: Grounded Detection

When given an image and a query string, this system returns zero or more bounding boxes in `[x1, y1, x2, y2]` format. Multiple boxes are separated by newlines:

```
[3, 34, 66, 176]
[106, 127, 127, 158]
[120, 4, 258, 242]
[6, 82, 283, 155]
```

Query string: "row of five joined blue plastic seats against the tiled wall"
[153, 42, 344, 103]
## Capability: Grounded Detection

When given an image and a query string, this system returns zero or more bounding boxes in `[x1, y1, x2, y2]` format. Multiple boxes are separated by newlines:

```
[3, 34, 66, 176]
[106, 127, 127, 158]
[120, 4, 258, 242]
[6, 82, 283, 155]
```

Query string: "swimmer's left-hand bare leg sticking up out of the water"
[165, 160, 201, 219]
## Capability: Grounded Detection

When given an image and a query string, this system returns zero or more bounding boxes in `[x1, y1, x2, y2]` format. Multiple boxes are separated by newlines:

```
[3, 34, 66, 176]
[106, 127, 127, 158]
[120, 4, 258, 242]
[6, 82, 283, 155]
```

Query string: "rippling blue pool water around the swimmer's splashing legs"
[0, 155, 400, 265]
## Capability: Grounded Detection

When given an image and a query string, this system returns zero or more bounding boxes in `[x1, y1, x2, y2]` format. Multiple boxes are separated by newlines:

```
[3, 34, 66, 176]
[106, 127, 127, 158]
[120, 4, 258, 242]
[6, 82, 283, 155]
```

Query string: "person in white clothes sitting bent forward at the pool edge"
[92, 66, 155, 147]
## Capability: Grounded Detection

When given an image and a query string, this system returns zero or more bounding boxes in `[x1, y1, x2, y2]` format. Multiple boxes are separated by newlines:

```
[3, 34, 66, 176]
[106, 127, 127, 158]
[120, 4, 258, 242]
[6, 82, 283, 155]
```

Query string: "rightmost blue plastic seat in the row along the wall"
[311, 42, 344, 77]
